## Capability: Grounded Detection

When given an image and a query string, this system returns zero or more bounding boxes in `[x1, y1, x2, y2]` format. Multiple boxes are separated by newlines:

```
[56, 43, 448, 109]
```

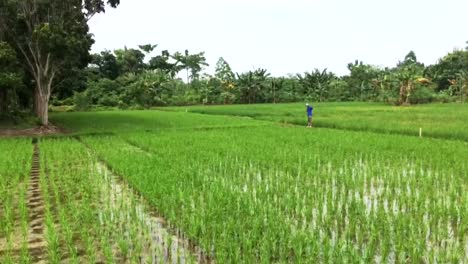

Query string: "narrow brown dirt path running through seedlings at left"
[26, 144, 47, 263]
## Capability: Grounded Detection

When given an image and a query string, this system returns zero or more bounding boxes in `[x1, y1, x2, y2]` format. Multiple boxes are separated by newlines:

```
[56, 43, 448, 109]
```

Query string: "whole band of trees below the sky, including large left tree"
[0, 0, 468, 125]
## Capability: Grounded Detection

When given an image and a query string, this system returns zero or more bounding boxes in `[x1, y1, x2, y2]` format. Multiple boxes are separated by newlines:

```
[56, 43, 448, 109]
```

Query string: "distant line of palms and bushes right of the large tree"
[67, 44, 468, 110]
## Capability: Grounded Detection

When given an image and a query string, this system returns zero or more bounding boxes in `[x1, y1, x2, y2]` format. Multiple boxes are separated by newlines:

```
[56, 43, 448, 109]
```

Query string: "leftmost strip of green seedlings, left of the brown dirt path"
[0, 139, 32, 263]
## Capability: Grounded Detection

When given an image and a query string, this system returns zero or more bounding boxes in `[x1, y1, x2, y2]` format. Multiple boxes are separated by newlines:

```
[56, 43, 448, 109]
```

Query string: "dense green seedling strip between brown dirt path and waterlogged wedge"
[41, 139, 108, 263]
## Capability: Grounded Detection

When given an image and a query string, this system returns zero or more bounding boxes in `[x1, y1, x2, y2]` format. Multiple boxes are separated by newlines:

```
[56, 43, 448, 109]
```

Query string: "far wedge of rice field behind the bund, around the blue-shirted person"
[163, 102, 468, 141]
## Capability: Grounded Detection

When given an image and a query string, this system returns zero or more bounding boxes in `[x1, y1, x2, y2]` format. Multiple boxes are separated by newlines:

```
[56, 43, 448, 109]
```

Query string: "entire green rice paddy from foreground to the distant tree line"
[0, 103, 468, 263]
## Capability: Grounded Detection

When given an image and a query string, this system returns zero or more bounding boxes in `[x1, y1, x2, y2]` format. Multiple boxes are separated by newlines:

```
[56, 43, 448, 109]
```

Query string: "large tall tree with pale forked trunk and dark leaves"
[0, 0, 120, 126]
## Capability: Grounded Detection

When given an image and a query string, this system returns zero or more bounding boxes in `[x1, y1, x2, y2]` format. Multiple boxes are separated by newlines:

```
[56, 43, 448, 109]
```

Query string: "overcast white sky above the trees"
[90, 0, 468, 76]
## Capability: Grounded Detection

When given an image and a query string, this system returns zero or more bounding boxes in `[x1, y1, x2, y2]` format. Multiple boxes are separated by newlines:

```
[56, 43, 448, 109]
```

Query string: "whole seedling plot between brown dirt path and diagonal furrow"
[36, 139, 196, 263]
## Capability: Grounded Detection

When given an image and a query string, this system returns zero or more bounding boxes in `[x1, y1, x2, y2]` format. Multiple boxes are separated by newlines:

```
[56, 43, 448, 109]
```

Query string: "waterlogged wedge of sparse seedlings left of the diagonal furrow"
[95, 162, 209, 263]
